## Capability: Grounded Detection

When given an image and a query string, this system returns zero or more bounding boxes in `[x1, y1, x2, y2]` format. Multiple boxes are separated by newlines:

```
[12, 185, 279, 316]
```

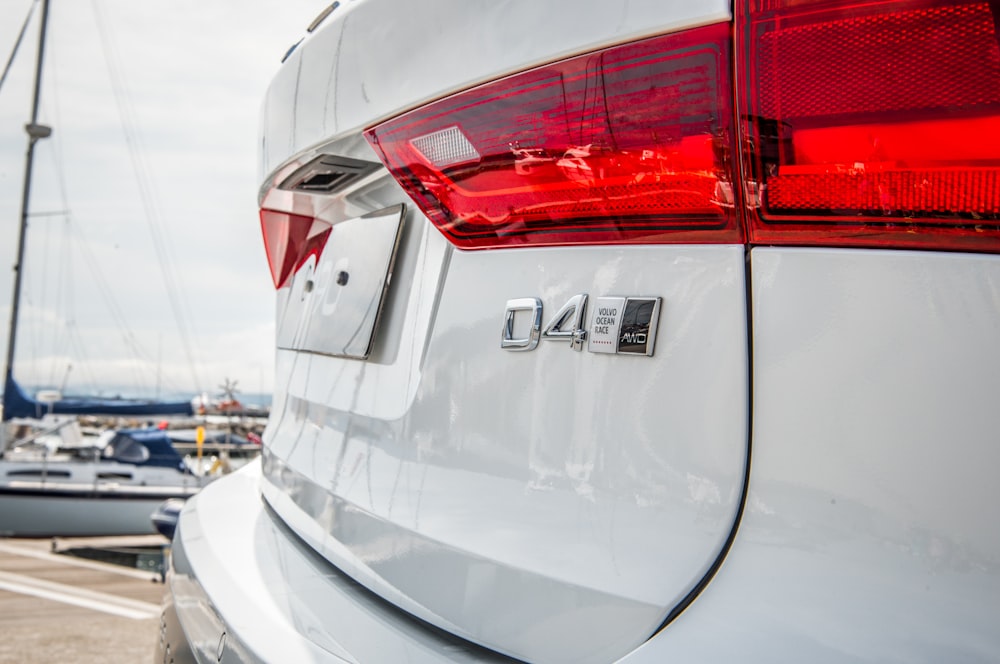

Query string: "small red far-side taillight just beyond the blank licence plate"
[260, 209, 330, 288]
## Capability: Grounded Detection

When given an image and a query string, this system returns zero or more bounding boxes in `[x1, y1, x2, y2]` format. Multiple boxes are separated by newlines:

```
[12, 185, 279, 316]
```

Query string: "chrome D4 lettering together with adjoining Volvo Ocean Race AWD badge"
[500, 293, 662, 356]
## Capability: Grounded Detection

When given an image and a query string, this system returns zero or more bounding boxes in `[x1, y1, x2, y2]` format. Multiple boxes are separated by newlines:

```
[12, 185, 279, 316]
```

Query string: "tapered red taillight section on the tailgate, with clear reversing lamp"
[365, 24, 743, 249]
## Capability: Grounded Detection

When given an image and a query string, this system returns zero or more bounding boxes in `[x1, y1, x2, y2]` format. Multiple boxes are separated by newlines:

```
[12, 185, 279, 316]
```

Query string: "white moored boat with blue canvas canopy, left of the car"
[0, 419, 210, 537]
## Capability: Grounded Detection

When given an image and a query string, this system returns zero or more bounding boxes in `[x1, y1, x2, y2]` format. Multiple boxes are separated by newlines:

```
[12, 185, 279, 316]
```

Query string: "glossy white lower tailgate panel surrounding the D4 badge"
[265, 236, 747, 661]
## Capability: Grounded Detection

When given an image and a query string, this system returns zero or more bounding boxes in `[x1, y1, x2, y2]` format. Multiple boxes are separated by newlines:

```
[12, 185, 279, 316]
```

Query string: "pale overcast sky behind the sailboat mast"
[0, 0, 328, 394]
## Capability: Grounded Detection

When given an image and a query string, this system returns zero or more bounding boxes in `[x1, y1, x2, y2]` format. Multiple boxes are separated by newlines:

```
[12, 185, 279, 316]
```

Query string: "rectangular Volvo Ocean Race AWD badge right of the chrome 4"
[587, 297, 660, 356]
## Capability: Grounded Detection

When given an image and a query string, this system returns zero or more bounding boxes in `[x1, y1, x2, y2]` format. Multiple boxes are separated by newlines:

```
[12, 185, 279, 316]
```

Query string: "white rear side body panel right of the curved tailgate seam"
[626, 249, 1000, 662]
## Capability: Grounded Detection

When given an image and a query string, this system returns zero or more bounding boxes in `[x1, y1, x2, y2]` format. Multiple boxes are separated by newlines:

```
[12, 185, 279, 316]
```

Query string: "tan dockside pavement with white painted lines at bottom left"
[0, 535, 166, 664]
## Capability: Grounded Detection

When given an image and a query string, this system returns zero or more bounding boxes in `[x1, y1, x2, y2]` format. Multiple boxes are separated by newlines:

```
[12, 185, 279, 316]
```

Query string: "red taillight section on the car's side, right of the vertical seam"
[737, 0, 1000, 251]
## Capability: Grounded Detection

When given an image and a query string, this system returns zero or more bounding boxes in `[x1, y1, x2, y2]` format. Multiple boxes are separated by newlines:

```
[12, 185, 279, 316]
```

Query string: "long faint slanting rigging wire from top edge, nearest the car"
[91, 0, 202, 392]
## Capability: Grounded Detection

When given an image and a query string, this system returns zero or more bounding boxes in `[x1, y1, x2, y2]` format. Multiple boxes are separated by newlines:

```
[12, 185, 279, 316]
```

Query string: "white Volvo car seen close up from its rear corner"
[157, 0, 1000, 663]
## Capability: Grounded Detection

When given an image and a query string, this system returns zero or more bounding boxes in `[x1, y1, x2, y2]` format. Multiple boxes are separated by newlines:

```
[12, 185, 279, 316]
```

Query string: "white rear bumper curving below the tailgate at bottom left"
[161, 461, 507, 663]
